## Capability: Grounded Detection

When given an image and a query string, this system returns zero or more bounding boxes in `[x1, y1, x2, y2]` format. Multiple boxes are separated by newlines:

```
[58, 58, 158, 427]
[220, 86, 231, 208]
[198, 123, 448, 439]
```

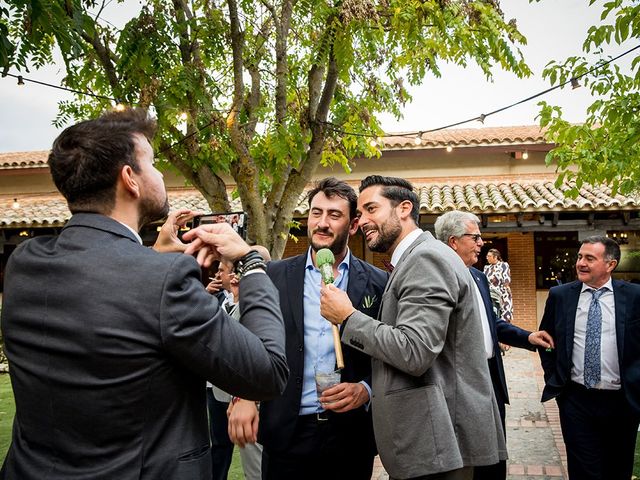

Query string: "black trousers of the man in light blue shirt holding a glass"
[262, 413, 374, 480]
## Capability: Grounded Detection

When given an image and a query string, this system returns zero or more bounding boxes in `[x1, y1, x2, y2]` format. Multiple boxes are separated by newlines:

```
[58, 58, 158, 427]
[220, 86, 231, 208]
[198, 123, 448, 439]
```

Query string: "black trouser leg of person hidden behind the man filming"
[207, 388, 233, 480]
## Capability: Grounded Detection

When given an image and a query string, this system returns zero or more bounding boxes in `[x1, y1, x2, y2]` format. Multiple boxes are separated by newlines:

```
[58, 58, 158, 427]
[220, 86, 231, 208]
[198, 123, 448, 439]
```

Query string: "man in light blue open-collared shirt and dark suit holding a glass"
[229, 178, 387, 480]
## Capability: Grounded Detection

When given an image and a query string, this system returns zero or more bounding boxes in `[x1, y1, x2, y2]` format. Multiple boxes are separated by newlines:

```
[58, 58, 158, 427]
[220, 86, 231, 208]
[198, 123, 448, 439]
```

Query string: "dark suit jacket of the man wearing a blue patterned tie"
[540, 280, 640, 413]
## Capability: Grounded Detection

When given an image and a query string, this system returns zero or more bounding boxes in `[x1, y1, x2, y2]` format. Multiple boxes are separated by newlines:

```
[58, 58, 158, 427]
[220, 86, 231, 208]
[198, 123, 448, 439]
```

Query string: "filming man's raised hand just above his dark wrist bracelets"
[182, 223, 250, 267]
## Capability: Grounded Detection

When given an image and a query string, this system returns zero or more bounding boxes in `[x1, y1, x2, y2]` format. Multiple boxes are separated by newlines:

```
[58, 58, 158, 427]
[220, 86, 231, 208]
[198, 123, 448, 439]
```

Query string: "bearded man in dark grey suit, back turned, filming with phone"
[0, 109, 287, 480]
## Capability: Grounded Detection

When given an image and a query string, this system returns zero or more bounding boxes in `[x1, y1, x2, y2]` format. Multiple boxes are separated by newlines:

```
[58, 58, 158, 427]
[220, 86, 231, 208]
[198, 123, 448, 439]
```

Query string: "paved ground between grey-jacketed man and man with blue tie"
[372, 348, 567, 480]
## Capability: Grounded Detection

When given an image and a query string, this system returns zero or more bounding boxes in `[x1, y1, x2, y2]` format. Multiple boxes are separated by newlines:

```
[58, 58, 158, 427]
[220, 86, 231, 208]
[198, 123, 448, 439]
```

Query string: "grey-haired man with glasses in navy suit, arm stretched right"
[435, 210, 553, 480]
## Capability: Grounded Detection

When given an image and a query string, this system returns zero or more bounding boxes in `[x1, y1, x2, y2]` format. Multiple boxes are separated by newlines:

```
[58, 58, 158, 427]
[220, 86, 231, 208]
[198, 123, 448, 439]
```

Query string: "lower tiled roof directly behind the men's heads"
[0, 178, 640, 228]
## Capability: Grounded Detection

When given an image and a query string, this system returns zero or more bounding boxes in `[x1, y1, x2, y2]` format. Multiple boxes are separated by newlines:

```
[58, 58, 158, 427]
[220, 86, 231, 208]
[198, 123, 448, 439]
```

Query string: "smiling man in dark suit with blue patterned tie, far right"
[540, 236, 640, 480]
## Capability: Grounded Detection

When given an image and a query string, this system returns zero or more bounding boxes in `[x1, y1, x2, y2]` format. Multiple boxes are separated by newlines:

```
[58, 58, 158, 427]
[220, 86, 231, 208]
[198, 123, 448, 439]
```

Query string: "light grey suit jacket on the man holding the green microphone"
[342, 232, 506, 478]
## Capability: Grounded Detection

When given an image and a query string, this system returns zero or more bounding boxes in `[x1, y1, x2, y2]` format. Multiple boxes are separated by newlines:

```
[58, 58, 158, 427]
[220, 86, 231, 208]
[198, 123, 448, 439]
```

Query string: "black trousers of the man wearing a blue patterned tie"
[556, 382, 640, 480]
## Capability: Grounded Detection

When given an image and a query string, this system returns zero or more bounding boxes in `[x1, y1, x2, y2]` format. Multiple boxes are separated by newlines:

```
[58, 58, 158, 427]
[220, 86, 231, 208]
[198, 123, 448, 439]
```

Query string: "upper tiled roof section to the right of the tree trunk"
[384, 125, 549, 150]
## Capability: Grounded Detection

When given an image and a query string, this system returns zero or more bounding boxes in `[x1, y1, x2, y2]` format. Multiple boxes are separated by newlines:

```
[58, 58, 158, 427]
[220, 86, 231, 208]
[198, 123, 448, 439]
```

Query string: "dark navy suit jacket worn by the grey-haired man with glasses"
[469, 267, 535, 404]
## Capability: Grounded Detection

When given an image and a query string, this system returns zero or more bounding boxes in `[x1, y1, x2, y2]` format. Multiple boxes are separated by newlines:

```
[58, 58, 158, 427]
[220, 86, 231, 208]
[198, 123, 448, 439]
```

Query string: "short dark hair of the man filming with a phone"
[49, 108, 156, 214]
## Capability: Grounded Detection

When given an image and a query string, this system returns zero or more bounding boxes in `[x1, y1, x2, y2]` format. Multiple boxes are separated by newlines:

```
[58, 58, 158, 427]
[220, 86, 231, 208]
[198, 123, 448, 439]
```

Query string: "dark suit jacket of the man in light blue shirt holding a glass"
[259, 253, 388, 455]
